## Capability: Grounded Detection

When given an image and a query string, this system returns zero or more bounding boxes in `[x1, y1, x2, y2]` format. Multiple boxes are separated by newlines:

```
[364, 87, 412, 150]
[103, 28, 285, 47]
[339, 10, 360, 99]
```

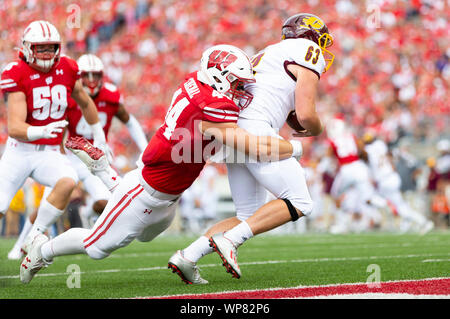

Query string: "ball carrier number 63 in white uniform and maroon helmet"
[169, 13, 334, 283]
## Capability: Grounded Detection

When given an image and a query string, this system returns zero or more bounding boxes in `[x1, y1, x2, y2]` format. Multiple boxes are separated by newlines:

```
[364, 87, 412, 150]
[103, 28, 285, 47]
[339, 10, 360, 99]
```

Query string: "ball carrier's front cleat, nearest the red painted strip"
[209, 233, 241, 279]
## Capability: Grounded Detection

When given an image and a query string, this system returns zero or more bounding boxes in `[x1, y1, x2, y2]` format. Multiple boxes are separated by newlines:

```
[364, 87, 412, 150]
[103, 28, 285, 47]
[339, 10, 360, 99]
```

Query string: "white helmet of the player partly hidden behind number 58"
[77, 54, 103, 96]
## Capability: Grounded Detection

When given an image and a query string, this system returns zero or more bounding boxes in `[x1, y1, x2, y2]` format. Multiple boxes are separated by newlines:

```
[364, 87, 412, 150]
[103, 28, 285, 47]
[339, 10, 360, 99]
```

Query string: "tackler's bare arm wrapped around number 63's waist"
[199, 121, 302, 162]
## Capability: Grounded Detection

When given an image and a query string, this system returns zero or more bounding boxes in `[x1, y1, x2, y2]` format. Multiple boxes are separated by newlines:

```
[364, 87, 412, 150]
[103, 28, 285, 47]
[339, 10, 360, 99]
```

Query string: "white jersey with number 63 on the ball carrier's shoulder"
[239, 39, 326, 129]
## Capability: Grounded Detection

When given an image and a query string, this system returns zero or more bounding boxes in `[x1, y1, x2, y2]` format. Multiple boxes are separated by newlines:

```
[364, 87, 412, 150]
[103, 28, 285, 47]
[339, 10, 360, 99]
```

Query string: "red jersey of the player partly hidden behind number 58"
[67, 82, 122, 142]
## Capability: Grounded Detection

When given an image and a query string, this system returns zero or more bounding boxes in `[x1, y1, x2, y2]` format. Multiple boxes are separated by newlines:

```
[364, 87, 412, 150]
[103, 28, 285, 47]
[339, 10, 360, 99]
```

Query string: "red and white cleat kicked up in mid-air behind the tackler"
[65, 136, 109, 172]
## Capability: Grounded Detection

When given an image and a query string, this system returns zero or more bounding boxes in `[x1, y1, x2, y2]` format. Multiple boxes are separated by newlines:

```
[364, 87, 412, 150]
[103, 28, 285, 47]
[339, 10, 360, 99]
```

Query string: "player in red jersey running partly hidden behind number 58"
[8, 54, 147, 259]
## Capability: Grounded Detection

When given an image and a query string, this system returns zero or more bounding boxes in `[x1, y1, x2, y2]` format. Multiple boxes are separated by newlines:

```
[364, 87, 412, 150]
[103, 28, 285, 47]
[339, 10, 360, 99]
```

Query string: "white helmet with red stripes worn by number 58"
[20, 20, 61, 72]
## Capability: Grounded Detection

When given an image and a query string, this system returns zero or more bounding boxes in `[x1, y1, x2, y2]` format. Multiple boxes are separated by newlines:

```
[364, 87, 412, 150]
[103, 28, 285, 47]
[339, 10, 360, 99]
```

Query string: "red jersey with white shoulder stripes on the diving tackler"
[142, 73, 239, 194]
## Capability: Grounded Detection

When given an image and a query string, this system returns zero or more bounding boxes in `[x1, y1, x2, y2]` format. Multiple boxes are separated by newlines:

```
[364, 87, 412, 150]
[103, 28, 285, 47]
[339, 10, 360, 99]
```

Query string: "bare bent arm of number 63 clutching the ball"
[288, 64, 323, 136]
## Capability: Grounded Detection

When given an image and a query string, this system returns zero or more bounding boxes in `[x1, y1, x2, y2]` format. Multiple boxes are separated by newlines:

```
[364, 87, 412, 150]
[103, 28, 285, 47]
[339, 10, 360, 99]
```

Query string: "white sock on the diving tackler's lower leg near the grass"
[41, 228, 91, 261]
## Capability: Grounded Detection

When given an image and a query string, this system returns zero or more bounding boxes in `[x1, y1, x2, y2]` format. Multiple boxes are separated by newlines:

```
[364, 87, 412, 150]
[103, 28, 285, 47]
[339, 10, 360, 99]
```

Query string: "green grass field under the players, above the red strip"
[0, 232, 450, 299]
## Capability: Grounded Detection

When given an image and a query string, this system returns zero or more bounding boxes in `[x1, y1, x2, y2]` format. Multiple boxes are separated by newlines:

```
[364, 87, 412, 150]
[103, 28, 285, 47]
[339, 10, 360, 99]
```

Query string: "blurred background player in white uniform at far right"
[363, 132, 434, 234]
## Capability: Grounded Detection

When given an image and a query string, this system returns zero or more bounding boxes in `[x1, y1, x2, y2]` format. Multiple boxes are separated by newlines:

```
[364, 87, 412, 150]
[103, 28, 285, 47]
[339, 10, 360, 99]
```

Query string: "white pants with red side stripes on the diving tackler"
[83, 169, 179, 259]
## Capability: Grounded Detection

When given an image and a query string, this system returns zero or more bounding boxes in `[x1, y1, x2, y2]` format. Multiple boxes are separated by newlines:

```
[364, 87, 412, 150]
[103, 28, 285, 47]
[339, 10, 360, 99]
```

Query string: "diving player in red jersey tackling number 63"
[20, 45, 302, 283]
